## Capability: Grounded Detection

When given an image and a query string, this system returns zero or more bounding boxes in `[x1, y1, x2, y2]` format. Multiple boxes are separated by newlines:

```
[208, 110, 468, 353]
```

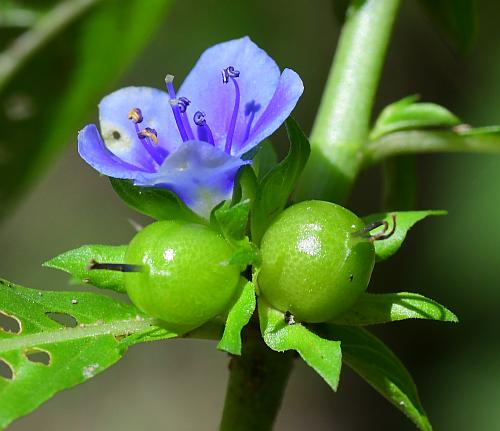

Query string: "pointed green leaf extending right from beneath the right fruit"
[332, 292, 458, 326]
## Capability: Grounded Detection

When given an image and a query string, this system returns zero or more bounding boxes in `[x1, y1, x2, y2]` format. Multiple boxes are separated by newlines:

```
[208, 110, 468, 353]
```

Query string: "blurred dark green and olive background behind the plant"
[0, 0, 500, 431]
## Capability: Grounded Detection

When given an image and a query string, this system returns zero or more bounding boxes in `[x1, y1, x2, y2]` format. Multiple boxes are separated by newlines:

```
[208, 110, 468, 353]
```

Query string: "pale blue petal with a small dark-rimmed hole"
[99, 87, 182, 170]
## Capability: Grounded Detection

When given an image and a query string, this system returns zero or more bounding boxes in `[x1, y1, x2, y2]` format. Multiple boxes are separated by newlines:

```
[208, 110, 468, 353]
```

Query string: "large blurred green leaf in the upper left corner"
[0, 0, 173, 215]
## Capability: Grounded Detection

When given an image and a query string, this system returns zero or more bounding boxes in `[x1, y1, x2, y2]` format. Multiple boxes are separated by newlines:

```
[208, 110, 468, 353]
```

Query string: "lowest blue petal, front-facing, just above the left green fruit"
[135, 141, 248, 218]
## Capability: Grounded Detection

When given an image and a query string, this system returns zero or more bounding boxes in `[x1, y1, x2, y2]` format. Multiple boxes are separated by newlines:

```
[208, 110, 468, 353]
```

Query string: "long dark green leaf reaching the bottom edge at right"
[322, 325, 432, 431]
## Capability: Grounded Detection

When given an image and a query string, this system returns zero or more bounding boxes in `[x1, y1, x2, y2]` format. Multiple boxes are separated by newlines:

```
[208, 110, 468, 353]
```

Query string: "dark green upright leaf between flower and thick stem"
[252, 117, 311, 244]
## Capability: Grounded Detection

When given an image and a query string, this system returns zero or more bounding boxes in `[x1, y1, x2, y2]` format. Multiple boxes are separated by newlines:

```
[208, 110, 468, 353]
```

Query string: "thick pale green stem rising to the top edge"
[299, 0, 401, 202]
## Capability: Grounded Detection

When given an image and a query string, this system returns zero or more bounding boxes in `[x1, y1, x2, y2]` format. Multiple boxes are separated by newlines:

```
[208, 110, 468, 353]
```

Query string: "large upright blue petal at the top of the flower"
[178, 37, 280, 153]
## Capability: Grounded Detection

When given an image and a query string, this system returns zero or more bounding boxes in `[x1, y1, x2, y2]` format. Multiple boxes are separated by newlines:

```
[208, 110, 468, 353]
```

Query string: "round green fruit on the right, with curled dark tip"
[258, 201, 375, 323]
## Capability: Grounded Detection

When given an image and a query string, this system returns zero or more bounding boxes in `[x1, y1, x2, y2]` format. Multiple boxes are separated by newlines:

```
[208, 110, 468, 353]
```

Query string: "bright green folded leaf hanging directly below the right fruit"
[258, 298, 342, 391]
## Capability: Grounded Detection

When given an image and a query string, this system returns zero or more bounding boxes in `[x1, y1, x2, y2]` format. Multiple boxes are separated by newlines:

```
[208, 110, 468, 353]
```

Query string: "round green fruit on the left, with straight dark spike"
[125, 220, 240, 332]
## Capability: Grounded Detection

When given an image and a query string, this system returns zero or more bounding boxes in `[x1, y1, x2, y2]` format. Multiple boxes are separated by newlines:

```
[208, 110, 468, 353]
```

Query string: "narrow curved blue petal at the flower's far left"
[78, 124, 151, 179]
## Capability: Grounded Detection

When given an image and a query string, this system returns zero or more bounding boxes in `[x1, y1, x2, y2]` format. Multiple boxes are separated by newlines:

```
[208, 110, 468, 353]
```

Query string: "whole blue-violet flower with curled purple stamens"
[78, 37, 304, 217]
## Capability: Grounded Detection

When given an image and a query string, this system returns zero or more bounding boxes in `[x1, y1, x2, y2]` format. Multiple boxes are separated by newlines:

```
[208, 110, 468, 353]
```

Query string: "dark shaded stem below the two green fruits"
[220, 326, 294, 431]
